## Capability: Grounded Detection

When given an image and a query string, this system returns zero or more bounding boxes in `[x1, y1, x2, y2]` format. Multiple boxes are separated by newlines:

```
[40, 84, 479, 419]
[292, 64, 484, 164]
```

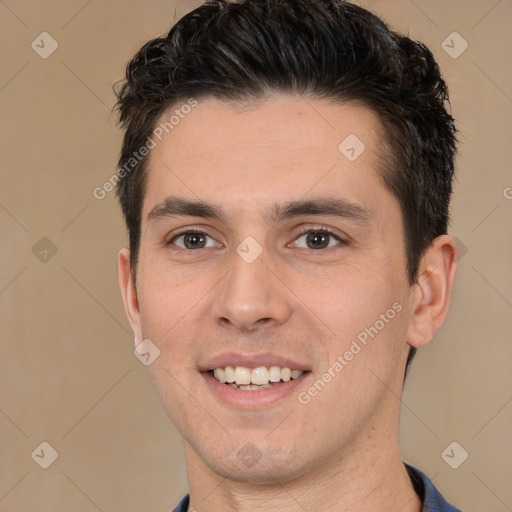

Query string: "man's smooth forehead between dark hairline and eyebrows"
[143, 96, 386, 224]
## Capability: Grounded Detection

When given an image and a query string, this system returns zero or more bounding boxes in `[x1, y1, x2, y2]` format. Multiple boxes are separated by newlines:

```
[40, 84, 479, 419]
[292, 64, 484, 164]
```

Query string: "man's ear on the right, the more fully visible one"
[407, 235, 458, 348]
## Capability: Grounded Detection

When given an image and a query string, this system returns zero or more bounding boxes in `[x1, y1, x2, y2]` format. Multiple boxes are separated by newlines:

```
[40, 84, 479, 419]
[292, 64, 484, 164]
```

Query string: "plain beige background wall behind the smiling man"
[0, 0, 512, 512]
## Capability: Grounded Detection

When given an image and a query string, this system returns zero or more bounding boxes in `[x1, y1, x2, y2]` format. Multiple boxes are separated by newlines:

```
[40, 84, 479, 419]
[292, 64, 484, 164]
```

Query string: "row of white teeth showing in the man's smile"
[213, 366, 304, 389]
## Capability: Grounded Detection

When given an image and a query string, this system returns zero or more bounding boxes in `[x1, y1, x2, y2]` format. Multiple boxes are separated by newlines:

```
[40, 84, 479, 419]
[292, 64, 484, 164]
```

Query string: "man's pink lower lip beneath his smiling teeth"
[201, 372, 310, 409]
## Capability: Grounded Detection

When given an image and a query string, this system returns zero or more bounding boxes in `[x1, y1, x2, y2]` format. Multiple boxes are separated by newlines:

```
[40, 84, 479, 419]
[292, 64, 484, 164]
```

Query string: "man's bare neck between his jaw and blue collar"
[185, 429, 422, 512]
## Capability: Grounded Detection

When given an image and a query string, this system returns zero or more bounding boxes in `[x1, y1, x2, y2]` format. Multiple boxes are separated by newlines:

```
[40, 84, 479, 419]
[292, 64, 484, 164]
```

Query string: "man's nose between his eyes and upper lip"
[212, 248, 291, 332]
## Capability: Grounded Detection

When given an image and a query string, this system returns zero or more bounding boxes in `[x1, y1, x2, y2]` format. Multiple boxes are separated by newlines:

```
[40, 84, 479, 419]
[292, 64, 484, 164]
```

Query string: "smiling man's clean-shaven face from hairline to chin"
[124, 97, 412, 482]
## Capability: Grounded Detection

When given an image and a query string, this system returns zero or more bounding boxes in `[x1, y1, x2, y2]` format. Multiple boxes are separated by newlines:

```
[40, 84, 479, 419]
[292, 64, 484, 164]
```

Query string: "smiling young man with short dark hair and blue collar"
[117, 0, 464, 512]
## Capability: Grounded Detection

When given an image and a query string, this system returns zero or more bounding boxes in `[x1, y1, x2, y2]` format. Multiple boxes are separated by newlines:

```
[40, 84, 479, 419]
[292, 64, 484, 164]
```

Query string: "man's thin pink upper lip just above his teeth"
[199, 352, 310, 372]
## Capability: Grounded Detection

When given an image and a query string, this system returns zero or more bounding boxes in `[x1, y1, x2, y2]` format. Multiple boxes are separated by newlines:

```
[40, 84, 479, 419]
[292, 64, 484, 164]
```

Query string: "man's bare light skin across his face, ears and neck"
[119, 96, 457, 512]
